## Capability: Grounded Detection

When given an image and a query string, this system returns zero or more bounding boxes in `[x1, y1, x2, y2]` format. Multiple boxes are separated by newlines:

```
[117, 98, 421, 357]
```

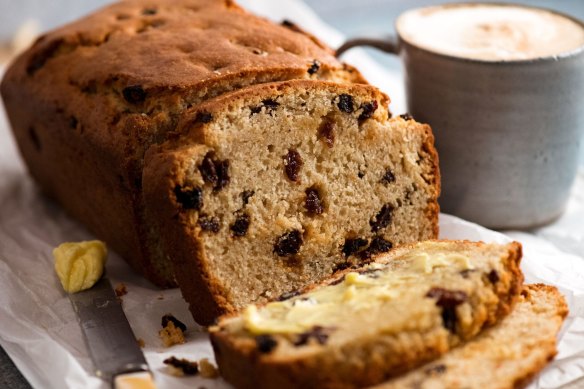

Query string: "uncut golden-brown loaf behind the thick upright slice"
[1, 0, 365, 286]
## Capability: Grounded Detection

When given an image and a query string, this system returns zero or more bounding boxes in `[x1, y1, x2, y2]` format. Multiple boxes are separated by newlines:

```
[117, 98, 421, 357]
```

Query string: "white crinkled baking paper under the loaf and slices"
[0, 0, 584, 389]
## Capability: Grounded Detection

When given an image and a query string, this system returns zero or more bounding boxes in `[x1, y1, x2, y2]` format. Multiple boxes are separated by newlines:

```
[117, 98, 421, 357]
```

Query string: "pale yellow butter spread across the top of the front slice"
[239, 252, 474, 335]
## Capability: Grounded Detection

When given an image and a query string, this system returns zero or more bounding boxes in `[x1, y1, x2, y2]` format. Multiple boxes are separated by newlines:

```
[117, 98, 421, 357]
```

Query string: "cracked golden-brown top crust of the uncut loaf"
[2, 0, 365, 163]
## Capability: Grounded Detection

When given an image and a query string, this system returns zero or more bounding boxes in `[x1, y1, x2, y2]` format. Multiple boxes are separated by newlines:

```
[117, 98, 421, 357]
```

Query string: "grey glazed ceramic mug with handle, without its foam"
[337, 4, 584, 229]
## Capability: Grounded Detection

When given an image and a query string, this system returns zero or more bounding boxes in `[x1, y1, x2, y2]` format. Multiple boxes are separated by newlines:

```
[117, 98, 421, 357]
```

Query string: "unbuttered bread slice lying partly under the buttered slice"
[376, 284, 568, 389]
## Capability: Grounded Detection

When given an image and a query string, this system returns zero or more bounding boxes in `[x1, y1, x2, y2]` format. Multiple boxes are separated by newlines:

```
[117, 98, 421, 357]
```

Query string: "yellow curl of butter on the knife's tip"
[53, 240, 107, 293]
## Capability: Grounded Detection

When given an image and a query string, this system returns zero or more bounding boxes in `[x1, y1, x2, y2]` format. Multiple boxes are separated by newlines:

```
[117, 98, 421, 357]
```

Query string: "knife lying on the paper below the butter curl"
[69, 275, 154, 388]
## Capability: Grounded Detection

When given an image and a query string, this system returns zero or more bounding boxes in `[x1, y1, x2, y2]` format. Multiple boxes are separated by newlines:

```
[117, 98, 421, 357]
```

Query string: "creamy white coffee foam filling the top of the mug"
[397, 4, 584, 61]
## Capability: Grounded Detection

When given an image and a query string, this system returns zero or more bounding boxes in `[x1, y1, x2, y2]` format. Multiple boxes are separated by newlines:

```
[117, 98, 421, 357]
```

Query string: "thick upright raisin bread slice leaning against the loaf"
[143, 80, 439, 324]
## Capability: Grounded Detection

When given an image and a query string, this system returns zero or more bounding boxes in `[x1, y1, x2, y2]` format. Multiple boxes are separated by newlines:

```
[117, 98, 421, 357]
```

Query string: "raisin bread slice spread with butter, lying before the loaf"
[211, 241, 523, 388]
